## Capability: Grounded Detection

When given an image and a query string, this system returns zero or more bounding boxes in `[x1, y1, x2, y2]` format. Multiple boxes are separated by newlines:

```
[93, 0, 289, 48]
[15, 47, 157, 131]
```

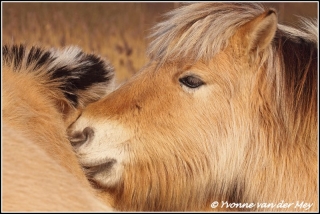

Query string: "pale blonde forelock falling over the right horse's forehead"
[148, 3, 264, 62]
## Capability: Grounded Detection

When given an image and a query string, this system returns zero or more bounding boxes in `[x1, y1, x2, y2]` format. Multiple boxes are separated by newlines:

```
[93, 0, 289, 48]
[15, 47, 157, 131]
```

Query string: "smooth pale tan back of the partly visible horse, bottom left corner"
[2, 126, 110, 211]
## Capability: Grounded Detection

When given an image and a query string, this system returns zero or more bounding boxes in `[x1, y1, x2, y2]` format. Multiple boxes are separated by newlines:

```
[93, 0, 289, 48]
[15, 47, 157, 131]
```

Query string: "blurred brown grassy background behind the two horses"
[2, 2, 318, 83]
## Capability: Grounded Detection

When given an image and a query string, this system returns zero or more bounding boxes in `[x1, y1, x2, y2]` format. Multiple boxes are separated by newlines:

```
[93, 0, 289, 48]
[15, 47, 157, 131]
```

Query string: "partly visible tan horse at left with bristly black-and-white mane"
[1, 44, 114, 211]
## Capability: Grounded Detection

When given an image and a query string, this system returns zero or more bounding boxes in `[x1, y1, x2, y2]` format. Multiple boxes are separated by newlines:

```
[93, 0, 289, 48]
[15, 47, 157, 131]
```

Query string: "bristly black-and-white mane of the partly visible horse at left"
[2, 44, 114, 106]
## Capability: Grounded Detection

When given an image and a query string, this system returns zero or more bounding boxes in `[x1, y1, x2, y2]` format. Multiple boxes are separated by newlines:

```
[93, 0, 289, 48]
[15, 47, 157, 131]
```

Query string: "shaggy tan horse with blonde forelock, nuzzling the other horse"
[67, 2, 319, 211]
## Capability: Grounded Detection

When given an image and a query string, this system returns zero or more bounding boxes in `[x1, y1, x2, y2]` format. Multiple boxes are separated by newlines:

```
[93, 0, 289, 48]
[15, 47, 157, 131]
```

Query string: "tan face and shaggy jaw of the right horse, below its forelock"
[69, 7, 276, 210]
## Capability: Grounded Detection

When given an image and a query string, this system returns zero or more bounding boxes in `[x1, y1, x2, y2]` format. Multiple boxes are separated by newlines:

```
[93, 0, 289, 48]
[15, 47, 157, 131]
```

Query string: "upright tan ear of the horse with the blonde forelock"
[239, 9, 278, 52]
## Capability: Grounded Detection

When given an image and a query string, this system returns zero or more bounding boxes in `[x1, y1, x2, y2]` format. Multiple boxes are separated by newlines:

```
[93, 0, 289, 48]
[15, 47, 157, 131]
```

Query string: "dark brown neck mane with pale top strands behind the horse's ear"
[274, 22, 318, 140]
